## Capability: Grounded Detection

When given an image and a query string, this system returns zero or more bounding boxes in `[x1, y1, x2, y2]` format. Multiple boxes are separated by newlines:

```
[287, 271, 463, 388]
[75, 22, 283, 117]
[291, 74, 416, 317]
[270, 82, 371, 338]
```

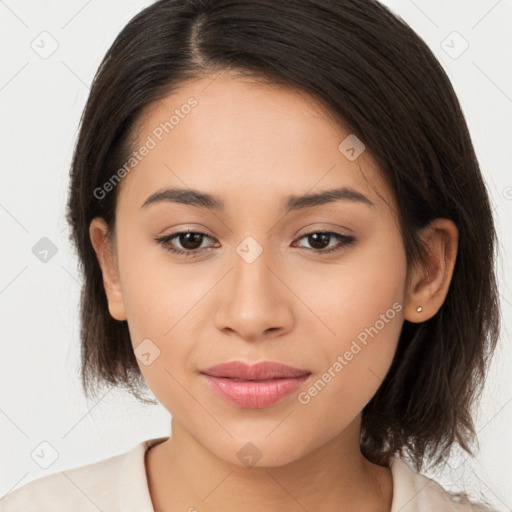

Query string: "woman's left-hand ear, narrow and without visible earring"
[89, 217, 126, 320]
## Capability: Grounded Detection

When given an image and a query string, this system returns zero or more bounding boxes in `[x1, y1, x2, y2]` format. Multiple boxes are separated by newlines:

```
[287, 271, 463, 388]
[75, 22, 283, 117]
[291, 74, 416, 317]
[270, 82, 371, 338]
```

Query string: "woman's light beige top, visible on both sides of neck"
[0, 437, 486, 512]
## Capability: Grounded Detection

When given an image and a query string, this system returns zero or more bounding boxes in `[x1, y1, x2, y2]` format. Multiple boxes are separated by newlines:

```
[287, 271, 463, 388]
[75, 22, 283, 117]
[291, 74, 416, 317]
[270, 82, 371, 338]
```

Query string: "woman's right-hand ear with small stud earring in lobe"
[404, 218, 459, 322]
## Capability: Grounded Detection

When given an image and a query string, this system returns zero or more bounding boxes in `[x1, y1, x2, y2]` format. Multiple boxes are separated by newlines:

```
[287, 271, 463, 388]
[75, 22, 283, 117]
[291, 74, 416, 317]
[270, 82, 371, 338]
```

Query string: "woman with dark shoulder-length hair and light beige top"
[1, 0, 499, 512]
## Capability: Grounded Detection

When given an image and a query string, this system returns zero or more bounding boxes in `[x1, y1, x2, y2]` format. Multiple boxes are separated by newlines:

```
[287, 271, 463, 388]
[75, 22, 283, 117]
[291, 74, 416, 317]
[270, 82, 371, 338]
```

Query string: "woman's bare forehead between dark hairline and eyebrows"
[117, 75, 392, 213]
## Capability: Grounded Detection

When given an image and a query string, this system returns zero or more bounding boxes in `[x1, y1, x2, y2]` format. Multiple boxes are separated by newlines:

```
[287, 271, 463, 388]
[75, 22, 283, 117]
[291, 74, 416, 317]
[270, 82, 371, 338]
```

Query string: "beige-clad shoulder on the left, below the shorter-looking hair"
[0, 440, 162, 512]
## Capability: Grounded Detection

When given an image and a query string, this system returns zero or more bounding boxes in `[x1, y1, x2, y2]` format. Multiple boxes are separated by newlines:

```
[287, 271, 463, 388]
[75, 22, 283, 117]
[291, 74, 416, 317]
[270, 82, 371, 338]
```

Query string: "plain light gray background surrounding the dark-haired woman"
[0, 0, 512, 511]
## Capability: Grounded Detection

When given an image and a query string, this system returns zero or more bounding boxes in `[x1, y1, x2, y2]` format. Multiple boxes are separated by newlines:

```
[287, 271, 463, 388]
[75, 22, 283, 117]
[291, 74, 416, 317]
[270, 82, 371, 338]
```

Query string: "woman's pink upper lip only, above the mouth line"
[201, 361, 311, 380]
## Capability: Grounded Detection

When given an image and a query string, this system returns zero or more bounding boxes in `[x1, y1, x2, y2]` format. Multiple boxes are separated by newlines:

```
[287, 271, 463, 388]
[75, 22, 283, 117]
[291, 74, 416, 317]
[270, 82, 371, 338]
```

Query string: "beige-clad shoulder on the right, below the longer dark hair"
[390, 457, 492, 512]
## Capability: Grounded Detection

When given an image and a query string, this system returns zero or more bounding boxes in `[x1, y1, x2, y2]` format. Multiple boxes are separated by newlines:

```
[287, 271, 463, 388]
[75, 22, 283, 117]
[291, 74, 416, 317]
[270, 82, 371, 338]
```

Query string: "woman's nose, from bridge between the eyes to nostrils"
[215, 244, 294, 342]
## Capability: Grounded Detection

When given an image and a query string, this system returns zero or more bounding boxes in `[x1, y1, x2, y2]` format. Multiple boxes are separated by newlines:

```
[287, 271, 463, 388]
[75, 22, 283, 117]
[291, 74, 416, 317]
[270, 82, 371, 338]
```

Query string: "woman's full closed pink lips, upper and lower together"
[200, 361, 311, 409]
